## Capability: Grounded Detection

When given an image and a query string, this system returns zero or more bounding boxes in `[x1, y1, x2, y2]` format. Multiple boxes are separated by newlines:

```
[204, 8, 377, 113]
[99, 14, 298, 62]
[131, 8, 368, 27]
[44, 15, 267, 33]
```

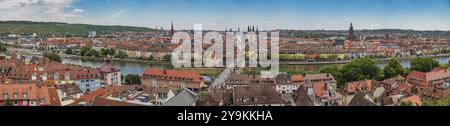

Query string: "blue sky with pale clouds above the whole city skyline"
[0, 0, 450, 30]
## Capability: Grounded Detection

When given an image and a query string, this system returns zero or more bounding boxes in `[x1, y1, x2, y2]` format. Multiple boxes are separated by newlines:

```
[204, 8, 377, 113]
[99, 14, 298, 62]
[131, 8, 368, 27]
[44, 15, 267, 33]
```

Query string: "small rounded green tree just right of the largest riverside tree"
[383, 59, 405, 79]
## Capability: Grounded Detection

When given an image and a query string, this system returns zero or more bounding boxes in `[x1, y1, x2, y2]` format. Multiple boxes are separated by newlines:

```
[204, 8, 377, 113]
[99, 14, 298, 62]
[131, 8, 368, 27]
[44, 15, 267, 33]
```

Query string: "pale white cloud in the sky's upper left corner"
[0, 0, 84, 22]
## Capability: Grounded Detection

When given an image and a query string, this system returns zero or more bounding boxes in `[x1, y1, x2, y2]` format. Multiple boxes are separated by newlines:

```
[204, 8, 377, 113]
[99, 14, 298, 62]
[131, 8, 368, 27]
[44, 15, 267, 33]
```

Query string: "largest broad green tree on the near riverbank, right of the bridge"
[340, 58, 381, 82]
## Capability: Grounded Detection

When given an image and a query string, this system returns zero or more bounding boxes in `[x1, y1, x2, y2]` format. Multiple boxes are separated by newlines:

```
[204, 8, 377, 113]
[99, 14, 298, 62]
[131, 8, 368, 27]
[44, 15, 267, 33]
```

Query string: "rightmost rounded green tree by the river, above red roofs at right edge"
[411, 58, 439, 72]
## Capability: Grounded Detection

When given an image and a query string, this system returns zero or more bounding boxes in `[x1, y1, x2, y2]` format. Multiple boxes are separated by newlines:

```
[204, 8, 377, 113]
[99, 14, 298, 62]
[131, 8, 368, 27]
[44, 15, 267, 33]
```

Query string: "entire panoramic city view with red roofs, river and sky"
[0, 0, 450, 106]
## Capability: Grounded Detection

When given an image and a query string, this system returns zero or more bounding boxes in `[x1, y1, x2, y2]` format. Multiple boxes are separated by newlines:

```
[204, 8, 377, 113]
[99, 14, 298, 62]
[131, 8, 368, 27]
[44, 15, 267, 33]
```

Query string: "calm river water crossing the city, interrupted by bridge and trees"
[62, 56, 450, 75]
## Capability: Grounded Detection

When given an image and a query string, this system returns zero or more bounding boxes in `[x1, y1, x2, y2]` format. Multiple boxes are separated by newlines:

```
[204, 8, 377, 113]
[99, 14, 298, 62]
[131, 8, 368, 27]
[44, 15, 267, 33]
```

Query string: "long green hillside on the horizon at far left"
[0, 21, 154, 37]
